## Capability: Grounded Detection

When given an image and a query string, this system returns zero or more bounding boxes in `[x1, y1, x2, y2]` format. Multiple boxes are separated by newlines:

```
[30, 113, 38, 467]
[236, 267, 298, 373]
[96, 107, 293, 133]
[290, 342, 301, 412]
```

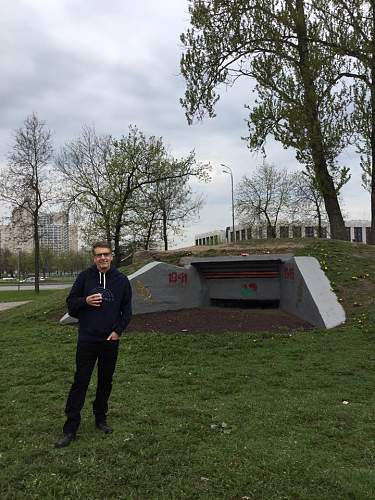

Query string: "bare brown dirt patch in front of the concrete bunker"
[127, 307, 313, 335]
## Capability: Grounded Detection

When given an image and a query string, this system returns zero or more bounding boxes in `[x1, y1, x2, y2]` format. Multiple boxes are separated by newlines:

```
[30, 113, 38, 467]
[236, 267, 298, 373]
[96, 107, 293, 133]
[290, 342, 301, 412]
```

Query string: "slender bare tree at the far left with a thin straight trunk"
[0, 113, 53, 293]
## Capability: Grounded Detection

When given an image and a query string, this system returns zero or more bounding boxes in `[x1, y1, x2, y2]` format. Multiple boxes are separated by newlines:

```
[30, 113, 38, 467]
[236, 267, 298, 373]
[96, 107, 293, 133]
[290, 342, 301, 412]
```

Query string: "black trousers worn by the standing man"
[63, 340, 119, 434]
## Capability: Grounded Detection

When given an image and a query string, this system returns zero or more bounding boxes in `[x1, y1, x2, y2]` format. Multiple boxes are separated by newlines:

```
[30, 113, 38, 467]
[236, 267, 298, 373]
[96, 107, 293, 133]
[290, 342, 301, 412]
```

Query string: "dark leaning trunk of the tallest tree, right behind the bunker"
[289, 0, 347, 240]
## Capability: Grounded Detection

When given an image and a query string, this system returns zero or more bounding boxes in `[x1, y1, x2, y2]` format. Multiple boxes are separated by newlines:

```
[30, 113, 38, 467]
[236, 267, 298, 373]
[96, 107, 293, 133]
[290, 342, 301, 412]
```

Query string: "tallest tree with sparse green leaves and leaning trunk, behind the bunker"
[181, 0, 348, 239]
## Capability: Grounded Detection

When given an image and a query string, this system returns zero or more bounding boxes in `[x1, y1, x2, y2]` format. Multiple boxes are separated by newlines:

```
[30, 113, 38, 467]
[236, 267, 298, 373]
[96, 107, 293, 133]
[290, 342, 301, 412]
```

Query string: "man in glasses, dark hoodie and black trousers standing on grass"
[55, 242, 132, 448]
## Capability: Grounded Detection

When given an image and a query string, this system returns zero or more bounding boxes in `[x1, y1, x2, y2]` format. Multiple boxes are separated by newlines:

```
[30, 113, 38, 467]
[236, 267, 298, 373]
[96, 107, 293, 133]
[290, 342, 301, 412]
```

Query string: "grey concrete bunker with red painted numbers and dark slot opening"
[60, 254, 345, 329]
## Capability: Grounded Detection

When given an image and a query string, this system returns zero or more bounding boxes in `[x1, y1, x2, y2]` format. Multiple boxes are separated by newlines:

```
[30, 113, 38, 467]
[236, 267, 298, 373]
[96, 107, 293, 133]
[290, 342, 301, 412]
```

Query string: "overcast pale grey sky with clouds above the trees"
[0, 0, 370, 246]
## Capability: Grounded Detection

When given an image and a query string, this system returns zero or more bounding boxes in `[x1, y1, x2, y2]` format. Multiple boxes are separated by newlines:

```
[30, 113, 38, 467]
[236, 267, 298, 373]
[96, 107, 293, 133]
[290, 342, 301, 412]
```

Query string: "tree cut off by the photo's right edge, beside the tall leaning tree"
[311, 0, 375, 244]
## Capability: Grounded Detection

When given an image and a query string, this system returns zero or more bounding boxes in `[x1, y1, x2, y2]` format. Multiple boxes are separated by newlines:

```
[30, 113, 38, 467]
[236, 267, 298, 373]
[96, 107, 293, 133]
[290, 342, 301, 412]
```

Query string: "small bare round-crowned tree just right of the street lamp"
[236, 163, 295, 238]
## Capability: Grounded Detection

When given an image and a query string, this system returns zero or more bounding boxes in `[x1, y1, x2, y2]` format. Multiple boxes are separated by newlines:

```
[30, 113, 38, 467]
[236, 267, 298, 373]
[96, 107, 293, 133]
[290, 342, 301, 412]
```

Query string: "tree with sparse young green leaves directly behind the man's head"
[57, 126, 207, 264]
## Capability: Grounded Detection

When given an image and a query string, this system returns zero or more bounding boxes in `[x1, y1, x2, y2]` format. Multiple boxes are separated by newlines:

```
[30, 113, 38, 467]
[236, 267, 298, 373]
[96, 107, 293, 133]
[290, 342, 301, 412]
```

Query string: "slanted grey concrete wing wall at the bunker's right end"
[280, 257, 345, 328]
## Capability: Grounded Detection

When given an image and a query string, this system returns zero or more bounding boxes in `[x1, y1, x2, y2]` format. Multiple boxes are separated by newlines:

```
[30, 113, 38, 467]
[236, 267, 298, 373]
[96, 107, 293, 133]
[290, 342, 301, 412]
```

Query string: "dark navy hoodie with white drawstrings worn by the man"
[66, 266, 132, 342]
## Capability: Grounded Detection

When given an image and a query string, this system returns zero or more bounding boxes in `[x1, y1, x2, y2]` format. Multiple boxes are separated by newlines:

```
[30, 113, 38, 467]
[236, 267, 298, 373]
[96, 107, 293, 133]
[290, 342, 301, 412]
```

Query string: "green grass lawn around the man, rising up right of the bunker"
[0, 242, 375, 500]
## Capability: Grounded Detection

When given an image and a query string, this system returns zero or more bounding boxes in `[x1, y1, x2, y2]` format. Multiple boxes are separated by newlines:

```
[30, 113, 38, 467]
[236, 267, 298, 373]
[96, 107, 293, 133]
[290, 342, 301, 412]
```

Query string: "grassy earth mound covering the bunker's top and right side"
[122, 239, 375, 322]
